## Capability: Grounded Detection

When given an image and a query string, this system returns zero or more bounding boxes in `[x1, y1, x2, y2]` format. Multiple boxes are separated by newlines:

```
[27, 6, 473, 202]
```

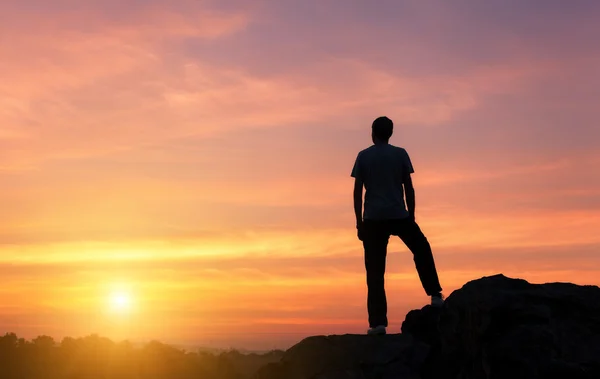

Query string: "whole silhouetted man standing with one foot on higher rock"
[352, 117, 444, 334]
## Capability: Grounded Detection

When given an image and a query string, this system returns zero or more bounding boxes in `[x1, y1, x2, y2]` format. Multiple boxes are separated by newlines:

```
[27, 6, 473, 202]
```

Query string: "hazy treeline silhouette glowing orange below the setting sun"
[0, 333, 283, 379]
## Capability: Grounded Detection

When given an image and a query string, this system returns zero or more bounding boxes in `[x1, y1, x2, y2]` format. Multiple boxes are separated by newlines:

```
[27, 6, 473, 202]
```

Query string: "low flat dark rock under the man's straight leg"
[255, 334, 429, 379]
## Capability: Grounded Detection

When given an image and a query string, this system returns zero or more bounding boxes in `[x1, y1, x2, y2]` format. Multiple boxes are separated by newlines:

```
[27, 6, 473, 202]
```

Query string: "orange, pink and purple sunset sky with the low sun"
[0, 0, 600, 349]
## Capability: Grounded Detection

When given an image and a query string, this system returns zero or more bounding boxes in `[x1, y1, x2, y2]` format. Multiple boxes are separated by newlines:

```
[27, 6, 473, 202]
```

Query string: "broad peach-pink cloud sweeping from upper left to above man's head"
[5, 0, 572, 171]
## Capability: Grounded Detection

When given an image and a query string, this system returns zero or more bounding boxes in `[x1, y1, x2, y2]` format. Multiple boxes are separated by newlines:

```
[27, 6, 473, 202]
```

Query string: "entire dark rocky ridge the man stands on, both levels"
[255, 275, 600, 379]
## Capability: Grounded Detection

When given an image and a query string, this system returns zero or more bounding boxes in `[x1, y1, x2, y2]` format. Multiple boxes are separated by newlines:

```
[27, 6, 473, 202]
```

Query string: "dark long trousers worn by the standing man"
[362, 218, 442, 328]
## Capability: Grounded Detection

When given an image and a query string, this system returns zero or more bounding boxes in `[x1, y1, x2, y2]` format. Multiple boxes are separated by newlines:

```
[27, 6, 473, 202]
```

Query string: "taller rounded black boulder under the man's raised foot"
[420, 275, 600, 379]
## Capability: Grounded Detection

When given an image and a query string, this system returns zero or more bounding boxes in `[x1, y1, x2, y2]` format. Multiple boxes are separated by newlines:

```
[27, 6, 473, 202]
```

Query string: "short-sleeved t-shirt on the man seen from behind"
[351, 144, 415, 220]
